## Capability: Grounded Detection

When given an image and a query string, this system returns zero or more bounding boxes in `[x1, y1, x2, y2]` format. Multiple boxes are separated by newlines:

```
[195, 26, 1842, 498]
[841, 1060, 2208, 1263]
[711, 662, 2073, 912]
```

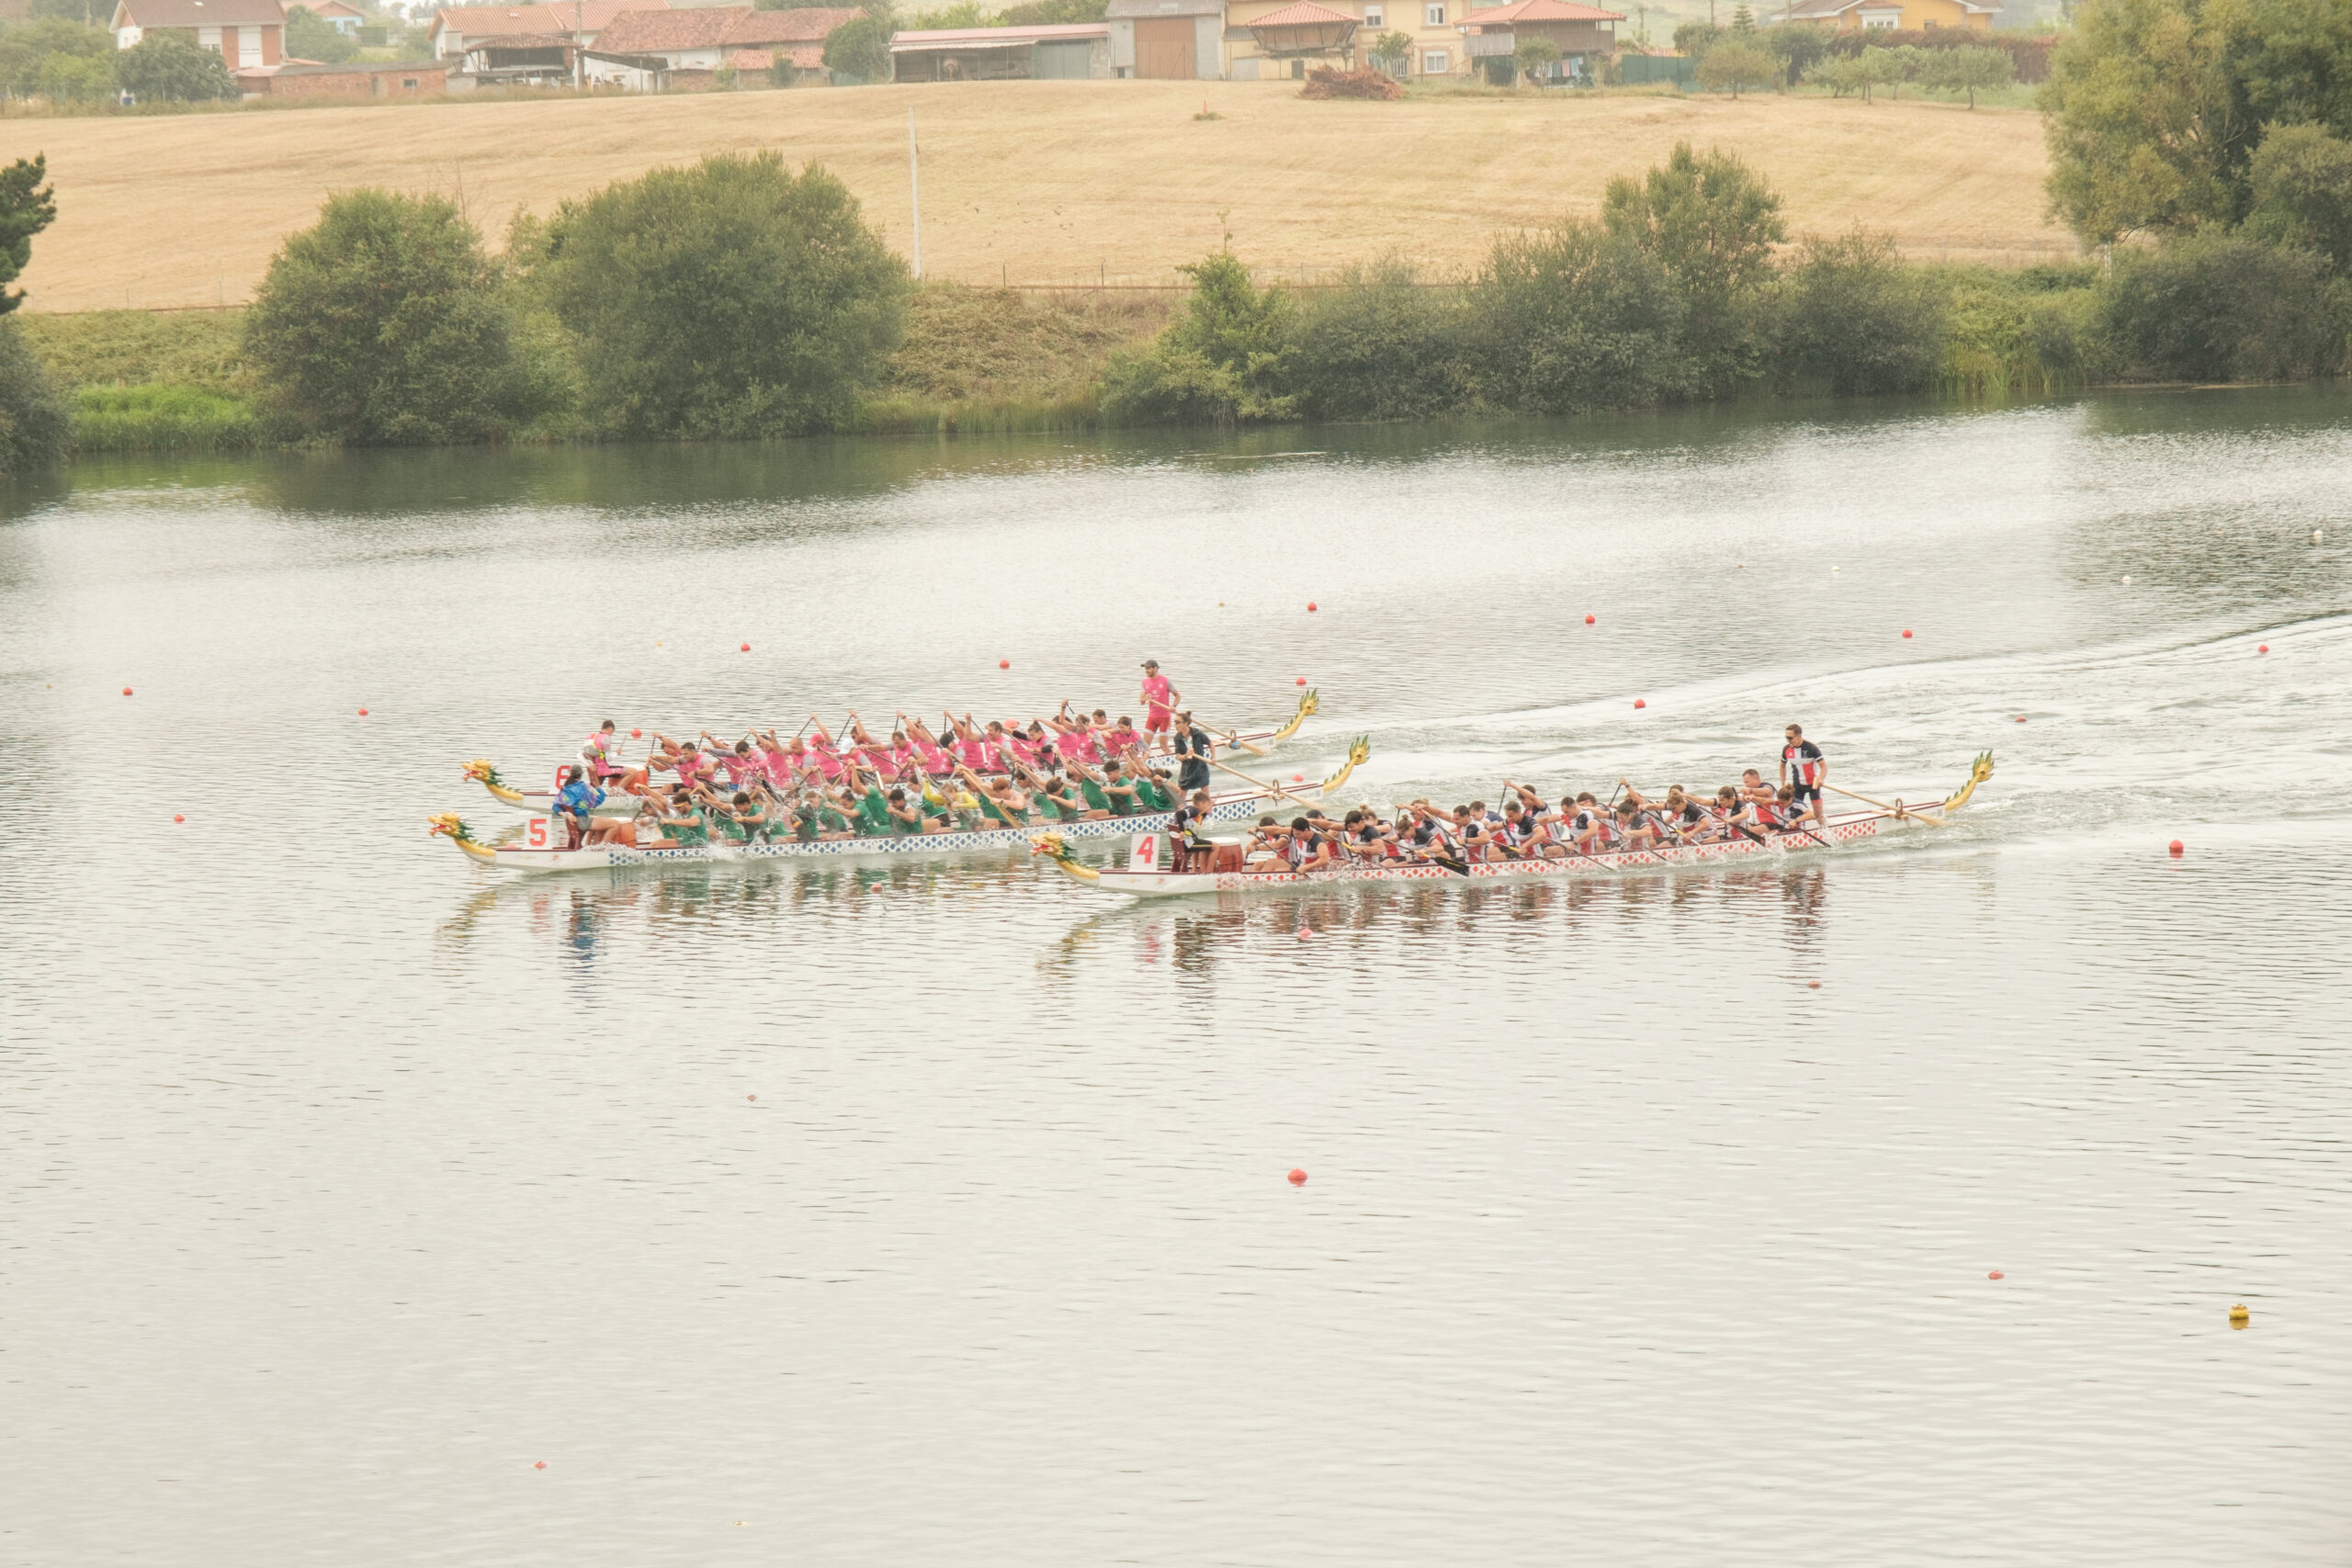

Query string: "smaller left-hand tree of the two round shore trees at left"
[244, 190, 526, 446]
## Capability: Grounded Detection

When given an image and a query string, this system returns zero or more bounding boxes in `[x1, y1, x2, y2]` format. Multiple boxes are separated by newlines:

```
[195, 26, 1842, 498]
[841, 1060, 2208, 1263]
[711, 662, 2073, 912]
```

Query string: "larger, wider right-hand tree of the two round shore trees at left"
[532, 152, 908, 437]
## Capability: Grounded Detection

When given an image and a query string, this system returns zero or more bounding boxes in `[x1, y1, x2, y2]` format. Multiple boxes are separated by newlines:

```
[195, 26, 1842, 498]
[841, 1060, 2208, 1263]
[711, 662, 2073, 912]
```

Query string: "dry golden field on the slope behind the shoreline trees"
[0, 83, 2072, 310]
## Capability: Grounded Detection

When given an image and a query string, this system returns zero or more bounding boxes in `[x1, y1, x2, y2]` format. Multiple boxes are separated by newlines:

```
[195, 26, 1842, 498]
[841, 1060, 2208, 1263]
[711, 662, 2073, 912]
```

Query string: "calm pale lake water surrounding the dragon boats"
[14, 390, 2352, 1568]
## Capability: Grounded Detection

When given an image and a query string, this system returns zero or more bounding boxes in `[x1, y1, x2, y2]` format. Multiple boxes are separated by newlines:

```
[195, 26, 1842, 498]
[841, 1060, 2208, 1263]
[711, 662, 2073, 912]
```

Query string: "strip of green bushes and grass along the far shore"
[14, 134, 2352, 465]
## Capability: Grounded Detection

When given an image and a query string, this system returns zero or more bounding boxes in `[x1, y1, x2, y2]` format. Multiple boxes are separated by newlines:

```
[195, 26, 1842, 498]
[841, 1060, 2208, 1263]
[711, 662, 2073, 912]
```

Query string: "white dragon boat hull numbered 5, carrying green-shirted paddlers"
[428, 740, 1371, 872]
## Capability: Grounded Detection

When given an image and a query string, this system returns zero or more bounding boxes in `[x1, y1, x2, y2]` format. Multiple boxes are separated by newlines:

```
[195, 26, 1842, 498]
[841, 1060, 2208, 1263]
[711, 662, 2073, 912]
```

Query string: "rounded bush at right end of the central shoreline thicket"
[1773, 228, 1945, 398]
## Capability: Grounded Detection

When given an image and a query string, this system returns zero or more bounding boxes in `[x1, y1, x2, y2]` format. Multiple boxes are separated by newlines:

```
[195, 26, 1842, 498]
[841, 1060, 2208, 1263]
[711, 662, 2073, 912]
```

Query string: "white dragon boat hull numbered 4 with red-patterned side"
[1030, 752, 1992, 898]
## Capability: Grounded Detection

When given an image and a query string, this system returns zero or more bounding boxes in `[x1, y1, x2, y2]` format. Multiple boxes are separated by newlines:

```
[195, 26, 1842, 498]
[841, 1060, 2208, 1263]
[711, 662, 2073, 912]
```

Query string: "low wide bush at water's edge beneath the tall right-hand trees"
[2100, 228, 2347, 381]
